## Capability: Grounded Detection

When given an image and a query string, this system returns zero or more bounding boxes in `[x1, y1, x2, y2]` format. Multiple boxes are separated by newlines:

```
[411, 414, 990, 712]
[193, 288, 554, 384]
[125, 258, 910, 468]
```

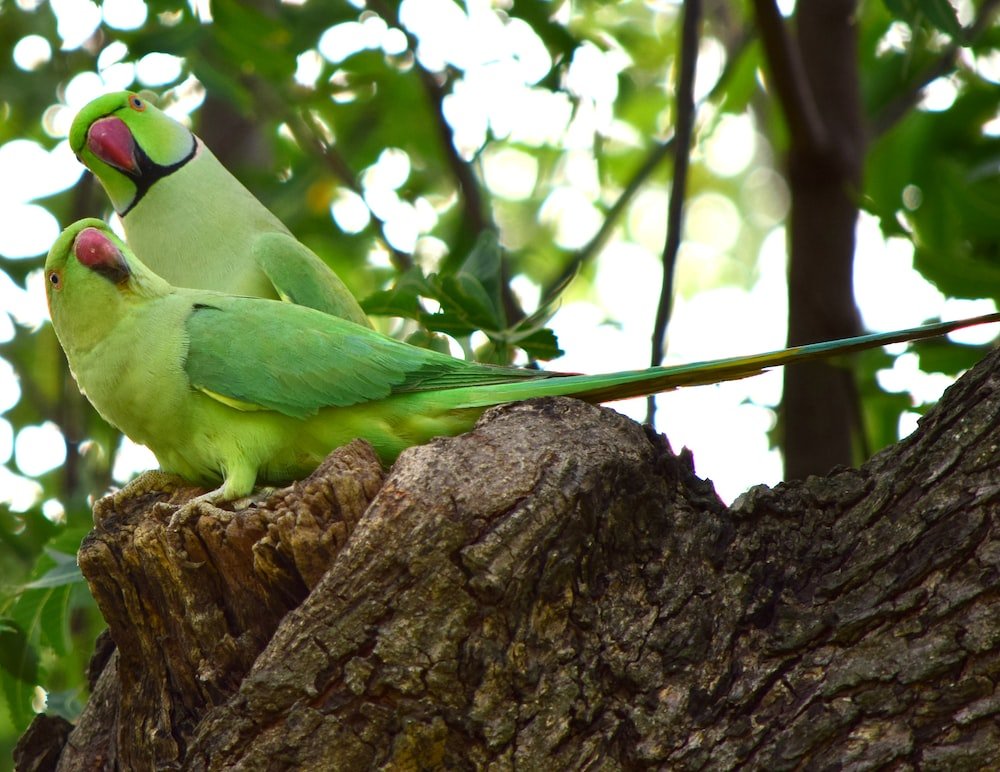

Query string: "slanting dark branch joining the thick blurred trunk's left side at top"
[753, 0, 829, 155]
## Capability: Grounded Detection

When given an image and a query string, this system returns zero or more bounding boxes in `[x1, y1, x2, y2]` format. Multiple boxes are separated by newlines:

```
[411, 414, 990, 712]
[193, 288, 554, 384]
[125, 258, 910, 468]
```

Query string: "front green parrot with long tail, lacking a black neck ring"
[45, 219, 1000, 501]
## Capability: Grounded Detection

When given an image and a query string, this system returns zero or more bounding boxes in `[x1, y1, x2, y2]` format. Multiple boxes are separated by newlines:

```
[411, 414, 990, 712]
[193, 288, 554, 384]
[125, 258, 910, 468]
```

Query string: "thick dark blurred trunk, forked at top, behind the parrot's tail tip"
[755, 0, 866, 479]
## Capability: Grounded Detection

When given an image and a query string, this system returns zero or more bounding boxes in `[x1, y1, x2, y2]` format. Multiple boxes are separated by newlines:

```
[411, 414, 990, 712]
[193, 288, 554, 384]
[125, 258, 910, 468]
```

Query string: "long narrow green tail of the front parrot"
[451, 313, 1000, 408]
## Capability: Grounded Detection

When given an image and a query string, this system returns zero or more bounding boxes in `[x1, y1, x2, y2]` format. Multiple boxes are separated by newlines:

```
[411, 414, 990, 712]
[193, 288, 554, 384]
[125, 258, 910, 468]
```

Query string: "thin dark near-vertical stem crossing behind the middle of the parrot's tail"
[646, 0, 701, 424]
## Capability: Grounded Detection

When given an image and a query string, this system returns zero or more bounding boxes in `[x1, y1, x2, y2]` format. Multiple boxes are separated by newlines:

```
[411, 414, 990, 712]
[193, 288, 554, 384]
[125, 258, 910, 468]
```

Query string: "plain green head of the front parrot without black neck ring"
[45, 219, 172, 351]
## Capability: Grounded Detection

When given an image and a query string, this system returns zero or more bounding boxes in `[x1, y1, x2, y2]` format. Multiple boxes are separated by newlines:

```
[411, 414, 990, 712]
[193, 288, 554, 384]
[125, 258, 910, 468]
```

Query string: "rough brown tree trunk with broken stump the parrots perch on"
[11, 346, 1000, 770]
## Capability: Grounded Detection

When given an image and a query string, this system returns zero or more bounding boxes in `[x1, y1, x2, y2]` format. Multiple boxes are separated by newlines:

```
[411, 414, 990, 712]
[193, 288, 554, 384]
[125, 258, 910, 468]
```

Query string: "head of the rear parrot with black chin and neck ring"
[69, 91, 198, 215]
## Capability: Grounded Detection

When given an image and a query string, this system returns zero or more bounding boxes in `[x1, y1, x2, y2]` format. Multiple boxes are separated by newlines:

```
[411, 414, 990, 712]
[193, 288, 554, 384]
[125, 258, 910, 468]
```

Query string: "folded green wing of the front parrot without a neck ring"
[185, 295, 552, 418]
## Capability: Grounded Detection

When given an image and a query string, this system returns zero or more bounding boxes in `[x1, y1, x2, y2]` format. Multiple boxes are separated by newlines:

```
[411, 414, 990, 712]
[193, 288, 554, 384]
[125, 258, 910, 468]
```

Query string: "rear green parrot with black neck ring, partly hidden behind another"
[69, 91, 371, 327]
